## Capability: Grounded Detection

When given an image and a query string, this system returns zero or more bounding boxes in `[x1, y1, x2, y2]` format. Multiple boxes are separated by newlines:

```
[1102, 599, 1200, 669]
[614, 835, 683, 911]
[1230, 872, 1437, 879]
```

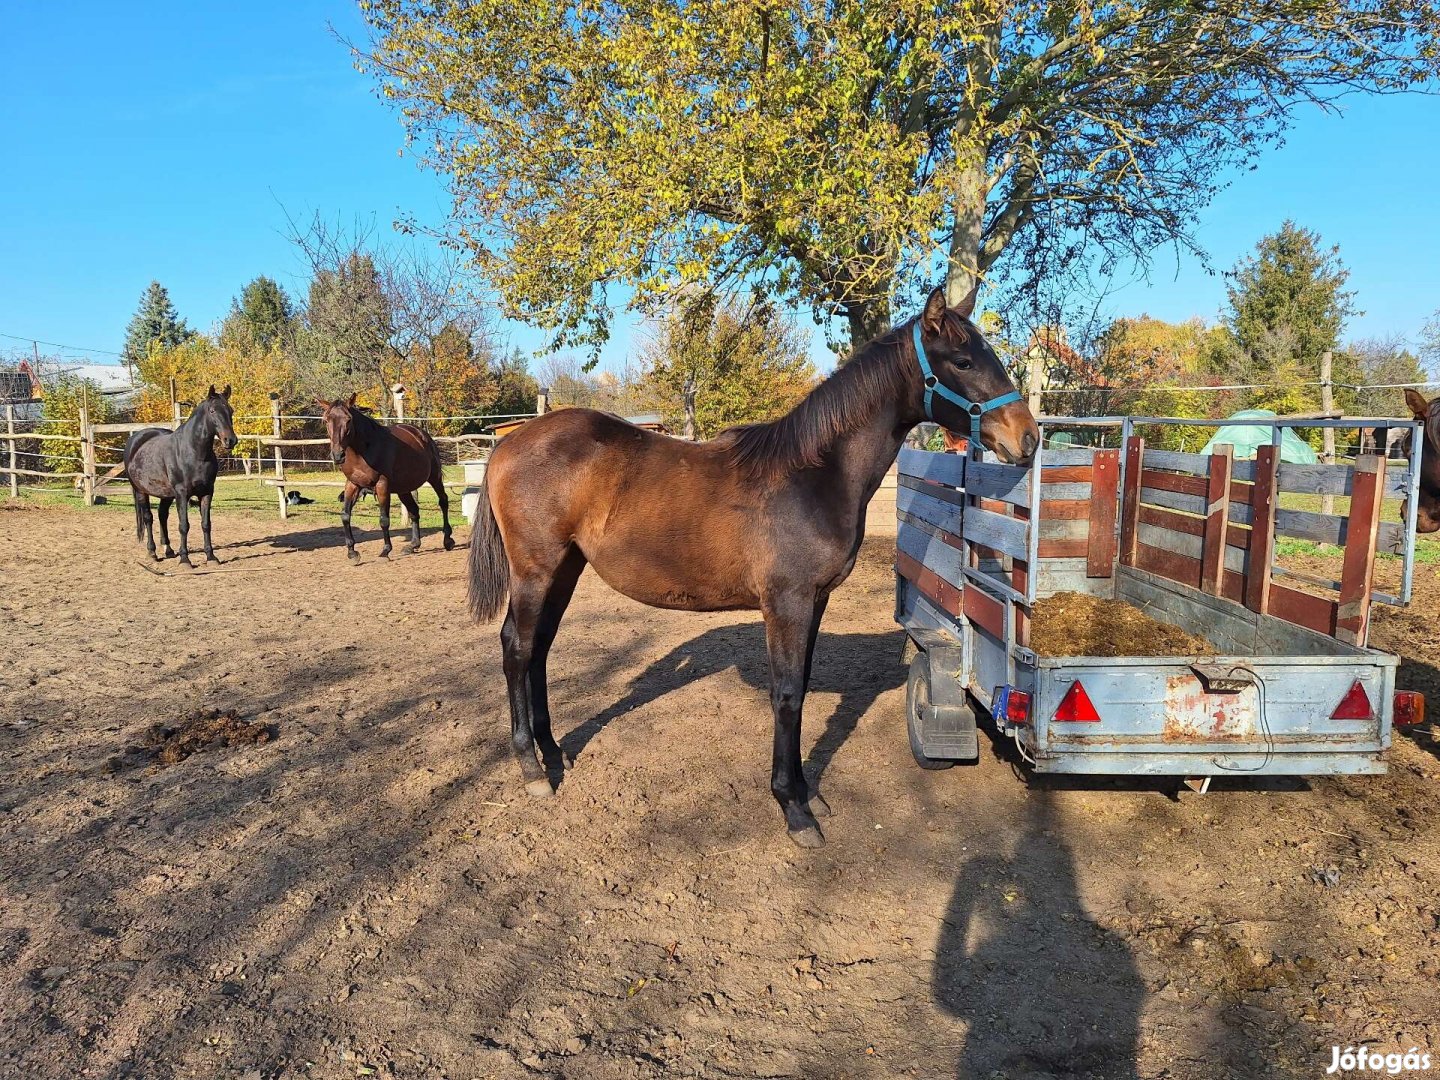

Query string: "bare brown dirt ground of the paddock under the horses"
[0, 508, 1440, 1080]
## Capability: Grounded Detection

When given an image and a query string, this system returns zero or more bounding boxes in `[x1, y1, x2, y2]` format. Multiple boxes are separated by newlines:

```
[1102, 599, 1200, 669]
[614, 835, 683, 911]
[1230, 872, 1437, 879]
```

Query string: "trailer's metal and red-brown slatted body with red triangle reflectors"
[896, 420, 1417, 778]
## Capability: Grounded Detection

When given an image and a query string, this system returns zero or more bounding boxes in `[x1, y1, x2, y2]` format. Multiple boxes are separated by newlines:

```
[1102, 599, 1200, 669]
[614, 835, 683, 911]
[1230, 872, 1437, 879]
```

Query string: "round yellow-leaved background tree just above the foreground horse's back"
[642, 297, 815, 439]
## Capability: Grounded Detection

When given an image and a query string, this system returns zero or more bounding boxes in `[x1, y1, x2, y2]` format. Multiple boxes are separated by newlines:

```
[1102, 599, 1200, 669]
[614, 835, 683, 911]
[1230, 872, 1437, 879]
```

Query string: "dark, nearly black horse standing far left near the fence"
[125, 383, 238, 567]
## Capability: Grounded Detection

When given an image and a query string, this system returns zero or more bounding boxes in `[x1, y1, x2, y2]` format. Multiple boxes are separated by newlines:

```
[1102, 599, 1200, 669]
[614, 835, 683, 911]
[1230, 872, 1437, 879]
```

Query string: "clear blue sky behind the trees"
[0, 0, 1440, 377]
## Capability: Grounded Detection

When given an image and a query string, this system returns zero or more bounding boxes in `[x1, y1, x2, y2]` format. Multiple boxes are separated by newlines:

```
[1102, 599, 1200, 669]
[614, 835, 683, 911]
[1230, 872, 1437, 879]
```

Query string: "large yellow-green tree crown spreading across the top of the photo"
[359, 0, 1440, 346]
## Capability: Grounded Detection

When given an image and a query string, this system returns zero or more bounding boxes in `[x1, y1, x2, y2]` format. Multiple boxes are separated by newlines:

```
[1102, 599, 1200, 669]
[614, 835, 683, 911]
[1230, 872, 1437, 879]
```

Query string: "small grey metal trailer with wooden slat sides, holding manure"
[896, 418, 1424, 783]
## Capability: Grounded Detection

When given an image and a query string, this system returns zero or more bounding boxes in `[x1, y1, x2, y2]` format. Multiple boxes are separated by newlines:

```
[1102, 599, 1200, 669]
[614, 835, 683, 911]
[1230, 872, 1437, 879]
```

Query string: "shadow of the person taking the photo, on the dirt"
[932, 791, 1145, 1080]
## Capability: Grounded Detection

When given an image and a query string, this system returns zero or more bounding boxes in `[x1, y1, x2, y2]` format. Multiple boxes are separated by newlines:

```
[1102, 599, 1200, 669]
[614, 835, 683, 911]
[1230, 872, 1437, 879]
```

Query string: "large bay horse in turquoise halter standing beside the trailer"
[469, 289, 1040, 847]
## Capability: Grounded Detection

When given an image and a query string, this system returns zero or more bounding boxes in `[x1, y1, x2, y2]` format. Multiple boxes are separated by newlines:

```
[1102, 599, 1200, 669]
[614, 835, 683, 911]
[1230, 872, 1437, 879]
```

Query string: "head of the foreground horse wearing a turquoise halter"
[910, 289, 1040, 465]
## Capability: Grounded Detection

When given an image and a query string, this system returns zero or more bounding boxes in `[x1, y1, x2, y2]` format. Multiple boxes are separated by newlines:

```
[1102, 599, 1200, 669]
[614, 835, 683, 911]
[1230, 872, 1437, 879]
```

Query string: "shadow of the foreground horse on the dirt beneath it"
[559, 622, 904, 785]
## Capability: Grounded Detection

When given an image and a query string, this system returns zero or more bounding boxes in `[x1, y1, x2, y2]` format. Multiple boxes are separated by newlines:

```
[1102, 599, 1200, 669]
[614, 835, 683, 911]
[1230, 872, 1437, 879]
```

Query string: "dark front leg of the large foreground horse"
[763, 590, 828, 848]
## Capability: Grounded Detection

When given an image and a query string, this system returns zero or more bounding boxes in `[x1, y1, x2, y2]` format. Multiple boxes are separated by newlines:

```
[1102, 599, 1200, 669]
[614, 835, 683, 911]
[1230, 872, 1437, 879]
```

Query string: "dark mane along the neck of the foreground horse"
[713, 330, 906, 480]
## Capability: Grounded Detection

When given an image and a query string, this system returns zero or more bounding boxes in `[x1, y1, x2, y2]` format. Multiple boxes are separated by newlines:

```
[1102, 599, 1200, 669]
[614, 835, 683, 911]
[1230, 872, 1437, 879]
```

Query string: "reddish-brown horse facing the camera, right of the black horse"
[315, 395, 455, 559]
